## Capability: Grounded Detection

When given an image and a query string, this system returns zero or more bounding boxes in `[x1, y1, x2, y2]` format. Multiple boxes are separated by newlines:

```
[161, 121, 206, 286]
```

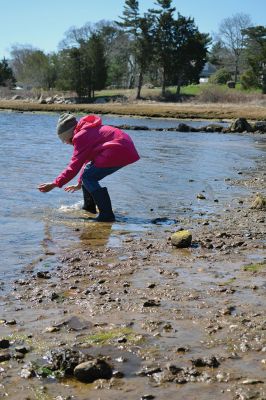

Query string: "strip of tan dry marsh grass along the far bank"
[0, 100, 266, 121]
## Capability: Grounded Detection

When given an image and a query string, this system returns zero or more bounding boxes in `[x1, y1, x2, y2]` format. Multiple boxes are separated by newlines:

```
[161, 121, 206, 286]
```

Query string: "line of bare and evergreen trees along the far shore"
[0, 0, 266, 97]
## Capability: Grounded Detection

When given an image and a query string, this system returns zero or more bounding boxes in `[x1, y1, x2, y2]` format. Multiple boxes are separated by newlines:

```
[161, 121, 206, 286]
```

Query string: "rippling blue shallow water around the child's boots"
[0, 112, 262, 277]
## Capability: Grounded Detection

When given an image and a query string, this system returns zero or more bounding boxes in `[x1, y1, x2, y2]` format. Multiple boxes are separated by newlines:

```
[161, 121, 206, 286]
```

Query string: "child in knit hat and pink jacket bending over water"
[38, 114, 139, 222]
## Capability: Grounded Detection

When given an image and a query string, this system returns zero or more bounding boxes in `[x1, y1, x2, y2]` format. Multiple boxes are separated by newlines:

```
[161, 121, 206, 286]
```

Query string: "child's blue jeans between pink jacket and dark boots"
[82, 163, 122, 193]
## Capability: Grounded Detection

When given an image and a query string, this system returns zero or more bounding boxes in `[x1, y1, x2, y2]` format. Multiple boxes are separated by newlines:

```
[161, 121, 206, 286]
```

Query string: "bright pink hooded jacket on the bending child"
[53, 115, 139, 187]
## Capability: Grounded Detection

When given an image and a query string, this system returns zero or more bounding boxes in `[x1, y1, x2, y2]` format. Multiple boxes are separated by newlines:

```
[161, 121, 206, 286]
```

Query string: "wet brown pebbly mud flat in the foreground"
[0, 166, 266, 400]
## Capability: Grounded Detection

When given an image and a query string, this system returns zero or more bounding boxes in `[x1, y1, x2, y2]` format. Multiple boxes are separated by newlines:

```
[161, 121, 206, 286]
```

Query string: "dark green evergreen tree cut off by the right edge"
[243, 26, 266, 93]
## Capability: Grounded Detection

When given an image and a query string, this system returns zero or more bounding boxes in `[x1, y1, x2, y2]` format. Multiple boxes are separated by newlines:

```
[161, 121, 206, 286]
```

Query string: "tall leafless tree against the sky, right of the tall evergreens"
[218, 13, 252, 82]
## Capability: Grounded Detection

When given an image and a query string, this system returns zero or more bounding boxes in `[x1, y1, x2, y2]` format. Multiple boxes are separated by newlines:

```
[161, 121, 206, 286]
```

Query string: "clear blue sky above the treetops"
[0, 0, 266, 59]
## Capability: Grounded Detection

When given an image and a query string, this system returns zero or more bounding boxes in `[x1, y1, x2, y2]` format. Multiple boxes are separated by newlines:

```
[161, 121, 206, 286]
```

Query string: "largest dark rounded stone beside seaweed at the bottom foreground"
[74, 359, 113, 383]
